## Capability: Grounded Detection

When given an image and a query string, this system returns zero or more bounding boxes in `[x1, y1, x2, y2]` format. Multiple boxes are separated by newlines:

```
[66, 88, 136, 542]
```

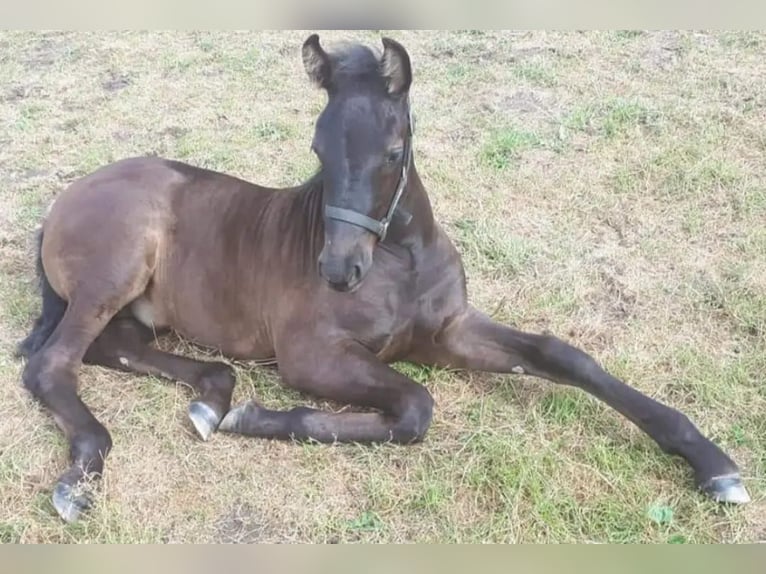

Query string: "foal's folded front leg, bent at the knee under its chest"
[219, 340, 433, 444]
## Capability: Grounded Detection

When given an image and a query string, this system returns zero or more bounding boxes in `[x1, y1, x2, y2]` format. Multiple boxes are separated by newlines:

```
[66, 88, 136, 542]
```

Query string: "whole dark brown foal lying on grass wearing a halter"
[20, 34, 749, 521]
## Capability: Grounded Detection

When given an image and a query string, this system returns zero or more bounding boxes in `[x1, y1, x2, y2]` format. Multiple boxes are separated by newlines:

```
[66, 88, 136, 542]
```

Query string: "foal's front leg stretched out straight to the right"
[410, 307, 750, 503]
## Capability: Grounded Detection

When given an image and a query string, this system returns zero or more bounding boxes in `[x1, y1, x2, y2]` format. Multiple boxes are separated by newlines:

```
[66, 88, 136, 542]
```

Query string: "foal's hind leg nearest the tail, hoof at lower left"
[23, 299, 127, 522]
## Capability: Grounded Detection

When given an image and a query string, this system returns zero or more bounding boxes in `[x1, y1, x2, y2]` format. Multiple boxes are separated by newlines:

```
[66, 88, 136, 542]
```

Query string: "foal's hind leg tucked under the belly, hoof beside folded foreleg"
[84, 317, 236, 440]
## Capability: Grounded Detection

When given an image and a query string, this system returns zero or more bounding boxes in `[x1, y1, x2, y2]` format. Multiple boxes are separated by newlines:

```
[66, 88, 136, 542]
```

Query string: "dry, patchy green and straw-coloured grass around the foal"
[0, 31, 766, 543]
